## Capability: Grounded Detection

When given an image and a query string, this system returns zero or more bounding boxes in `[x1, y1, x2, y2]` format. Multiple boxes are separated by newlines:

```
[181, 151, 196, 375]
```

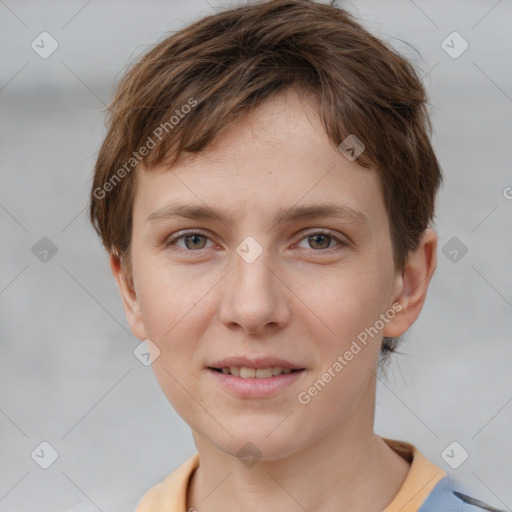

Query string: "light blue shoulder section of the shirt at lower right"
[418, 476, 505, 512]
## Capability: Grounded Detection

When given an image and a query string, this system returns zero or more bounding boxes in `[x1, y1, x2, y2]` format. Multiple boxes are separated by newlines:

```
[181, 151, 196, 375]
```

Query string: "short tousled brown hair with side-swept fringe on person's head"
[90, 0, 441, 362]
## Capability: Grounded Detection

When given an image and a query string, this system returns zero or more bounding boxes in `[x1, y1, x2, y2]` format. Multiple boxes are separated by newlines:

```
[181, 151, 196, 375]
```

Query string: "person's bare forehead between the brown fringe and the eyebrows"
[134, 90, 386, 229]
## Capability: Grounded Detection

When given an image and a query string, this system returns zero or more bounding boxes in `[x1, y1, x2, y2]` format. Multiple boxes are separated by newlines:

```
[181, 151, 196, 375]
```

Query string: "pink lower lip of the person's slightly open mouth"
[207, 368, 304, 398]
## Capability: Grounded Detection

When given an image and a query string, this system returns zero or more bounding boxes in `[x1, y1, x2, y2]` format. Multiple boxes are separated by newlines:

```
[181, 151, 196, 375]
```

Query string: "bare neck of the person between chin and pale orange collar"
[187, 378, 410, 512]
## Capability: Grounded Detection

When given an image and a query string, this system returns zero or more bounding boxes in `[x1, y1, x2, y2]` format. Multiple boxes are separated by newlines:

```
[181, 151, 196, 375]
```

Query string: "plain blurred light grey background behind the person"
[0, 0, 512, 512]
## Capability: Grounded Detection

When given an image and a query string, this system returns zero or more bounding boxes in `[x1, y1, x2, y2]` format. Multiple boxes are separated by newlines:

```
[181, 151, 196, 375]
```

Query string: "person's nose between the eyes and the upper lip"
[219, 244, 291, 335]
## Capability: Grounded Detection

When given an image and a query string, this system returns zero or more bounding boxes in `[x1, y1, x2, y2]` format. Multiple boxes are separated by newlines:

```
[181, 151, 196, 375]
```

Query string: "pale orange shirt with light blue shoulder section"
[135, 438, 500, 512]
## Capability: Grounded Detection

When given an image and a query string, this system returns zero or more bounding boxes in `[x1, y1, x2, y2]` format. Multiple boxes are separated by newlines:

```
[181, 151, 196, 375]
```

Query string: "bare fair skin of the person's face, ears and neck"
[111, 89, 437, 512]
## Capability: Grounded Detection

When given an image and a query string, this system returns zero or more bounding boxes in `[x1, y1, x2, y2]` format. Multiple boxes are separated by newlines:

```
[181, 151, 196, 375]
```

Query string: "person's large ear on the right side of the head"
[383, 228, 437, 337]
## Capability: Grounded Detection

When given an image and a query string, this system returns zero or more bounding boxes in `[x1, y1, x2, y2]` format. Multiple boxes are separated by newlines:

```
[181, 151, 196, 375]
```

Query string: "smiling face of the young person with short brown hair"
[113, 87, 432, 460]
